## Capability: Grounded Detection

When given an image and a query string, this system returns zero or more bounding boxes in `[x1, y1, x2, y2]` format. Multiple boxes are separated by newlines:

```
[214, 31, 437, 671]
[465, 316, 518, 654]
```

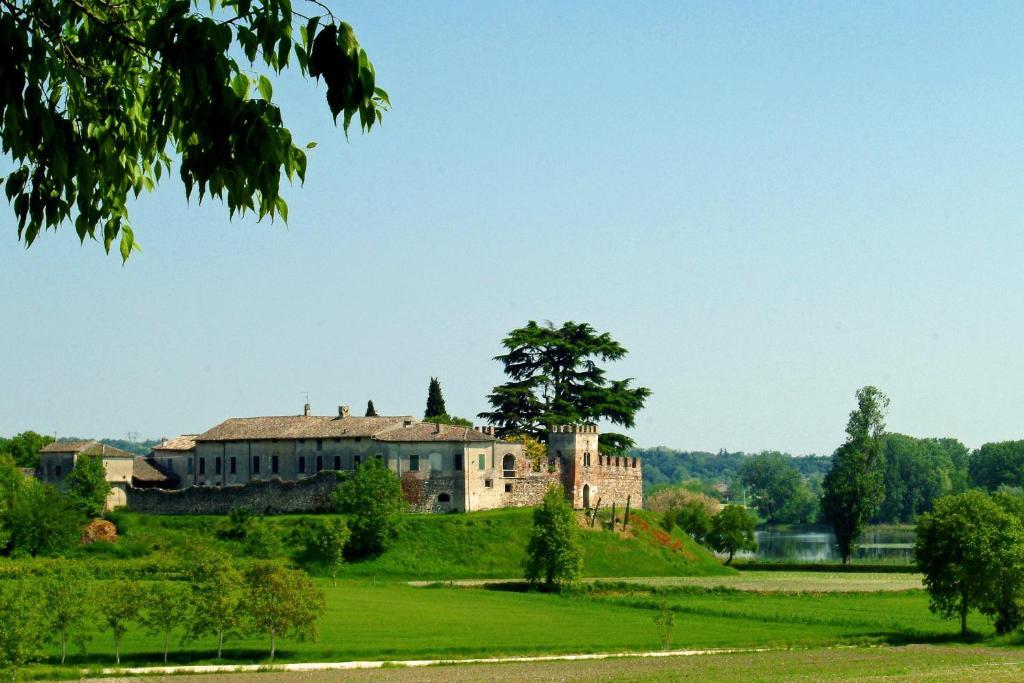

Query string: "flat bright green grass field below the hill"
[29, 577, 991, 666]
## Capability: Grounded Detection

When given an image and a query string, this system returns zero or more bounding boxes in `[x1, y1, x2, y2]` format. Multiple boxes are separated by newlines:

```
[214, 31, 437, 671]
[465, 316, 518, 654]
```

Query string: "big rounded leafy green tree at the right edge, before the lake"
[913, 490, 1024, 636]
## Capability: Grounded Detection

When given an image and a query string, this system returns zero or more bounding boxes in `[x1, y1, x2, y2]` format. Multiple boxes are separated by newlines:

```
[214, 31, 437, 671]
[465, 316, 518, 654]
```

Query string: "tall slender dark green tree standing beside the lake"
[821, 386, 889, 564]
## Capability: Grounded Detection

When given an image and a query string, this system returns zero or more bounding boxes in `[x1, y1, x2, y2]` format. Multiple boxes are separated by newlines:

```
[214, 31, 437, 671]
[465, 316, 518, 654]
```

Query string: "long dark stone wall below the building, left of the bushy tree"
[127, 472, 339, 515]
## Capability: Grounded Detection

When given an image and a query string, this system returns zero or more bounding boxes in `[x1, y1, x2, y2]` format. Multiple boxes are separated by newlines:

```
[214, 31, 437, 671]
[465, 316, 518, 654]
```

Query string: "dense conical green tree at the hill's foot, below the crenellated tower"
[523, 485, 583, 588]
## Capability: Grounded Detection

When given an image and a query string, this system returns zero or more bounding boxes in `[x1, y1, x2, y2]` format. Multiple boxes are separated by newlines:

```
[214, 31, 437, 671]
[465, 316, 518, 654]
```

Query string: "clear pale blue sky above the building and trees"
[0, 2, 1024, 454]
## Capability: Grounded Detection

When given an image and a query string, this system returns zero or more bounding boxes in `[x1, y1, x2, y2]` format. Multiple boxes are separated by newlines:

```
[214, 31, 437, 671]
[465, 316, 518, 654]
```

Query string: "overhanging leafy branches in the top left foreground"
[0, 0, 388, 259]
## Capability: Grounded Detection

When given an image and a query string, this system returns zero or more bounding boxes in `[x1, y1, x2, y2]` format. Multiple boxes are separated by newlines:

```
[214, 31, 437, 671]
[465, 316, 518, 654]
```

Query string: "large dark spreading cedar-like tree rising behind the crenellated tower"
[479, 321, 650, 449]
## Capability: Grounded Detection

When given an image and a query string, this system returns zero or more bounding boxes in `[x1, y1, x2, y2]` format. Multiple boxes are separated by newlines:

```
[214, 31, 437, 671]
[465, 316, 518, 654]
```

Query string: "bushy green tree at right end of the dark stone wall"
[334, 459, 407, 558]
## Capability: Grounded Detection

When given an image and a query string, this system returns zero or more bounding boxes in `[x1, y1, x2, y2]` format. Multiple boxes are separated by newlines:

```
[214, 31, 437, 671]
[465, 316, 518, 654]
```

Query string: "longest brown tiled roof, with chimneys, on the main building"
[196, 415, 415, 441]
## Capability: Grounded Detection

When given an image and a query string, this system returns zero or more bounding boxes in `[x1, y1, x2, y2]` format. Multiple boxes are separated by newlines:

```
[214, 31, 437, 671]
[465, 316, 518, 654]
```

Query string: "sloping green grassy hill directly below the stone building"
[99, 508, 733, 581]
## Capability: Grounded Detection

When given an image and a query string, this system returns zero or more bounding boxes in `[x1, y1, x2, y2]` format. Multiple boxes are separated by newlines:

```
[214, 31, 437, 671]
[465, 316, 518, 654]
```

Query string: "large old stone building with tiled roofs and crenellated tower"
[51, 403, 643, 513]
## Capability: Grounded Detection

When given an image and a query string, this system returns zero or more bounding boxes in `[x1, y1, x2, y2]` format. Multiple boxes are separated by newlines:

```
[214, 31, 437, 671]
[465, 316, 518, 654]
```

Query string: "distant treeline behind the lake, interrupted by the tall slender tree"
[631, 434, 1024, 523]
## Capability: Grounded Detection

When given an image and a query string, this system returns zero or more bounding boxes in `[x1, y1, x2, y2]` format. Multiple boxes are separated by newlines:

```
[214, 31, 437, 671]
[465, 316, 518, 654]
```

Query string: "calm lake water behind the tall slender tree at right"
[737, 527, 913, 563]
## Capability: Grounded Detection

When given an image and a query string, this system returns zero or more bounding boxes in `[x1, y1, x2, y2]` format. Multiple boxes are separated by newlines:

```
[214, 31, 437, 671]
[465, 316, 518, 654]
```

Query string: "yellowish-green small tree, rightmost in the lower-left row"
[242, 561, 326, 661]
